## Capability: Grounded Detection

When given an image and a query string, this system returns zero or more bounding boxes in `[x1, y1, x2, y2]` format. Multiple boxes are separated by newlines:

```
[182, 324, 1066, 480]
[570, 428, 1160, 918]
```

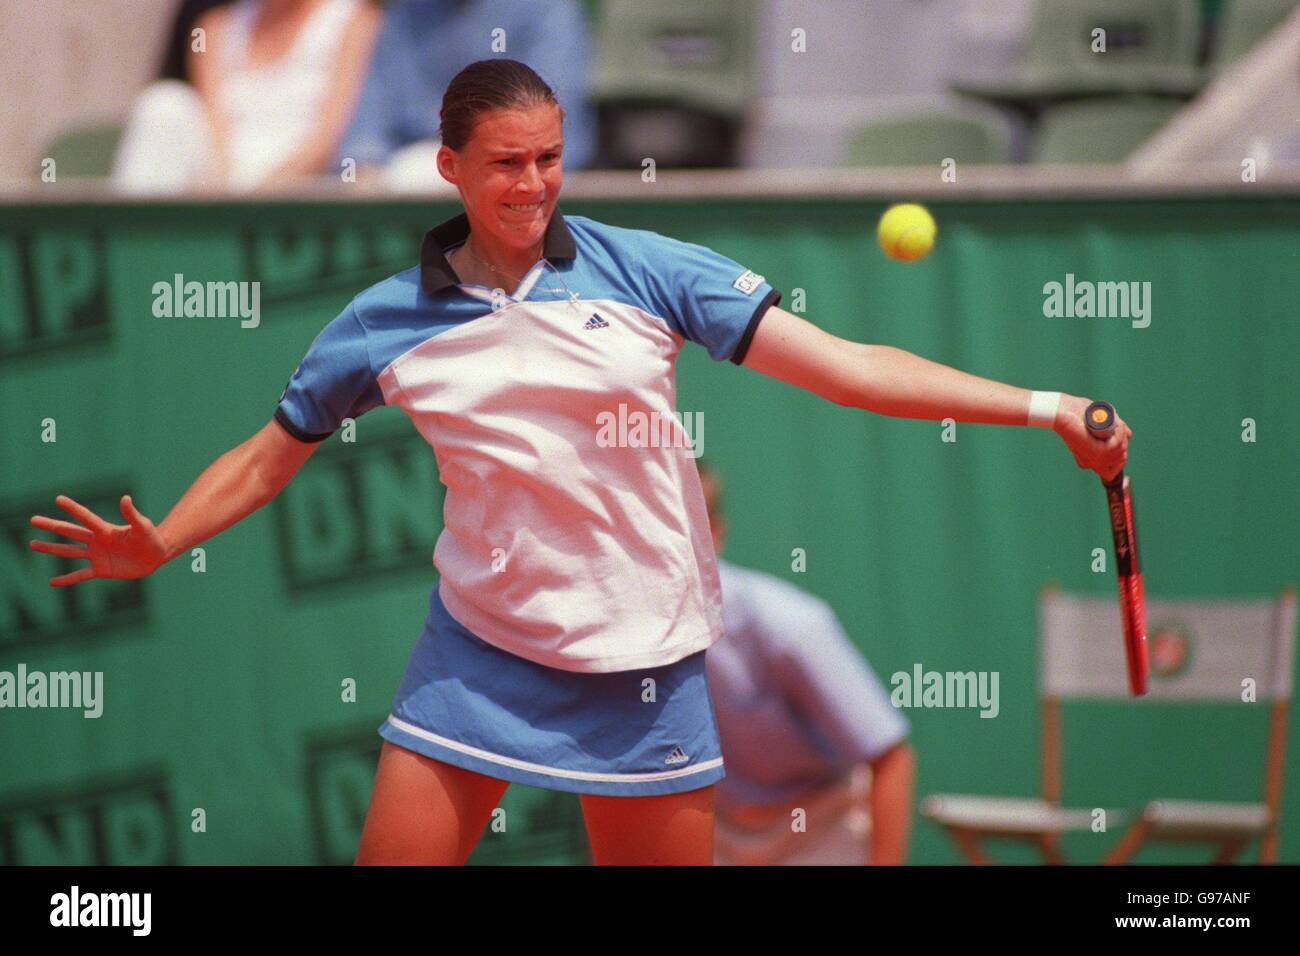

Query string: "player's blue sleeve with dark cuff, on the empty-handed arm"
[276, 304, 384, 441]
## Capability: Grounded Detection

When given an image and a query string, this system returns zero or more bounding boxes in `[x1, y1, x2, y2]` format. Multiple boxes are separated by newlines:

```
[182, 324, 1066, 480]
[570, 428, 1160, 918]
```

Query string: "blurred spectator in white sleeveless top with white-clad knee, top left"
[113, 0, 380, 193]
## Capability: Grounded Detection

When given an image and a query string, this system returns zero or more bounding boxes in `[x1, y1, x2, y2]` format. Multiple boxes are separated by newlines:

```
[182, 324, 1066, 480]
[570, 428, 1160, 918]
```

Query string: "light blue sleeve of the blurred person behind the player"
[762, 596, 909, 769]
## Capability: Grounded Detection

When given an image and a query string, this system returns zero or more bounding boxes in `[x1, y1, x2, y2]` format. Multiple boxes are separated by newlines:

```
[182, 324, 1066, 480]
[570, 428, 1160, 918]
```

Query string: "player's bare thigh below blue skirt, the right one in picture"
[582, 787, 714, 866]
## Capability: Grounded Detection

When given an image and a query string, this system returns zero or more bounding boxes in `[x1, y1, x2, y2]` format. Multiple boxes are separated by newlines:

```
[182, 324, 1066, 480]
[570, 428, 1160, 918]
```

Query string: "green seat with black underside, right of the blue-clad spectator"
[592, 0, 755, 166]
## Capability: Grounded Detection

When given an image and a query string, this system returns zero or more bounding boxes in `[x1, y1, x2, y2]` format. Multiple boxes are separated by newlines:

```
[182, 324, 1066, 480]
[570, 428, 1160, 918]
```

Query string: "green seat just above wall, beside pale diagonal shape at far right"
[1034, 96, 1183, 163]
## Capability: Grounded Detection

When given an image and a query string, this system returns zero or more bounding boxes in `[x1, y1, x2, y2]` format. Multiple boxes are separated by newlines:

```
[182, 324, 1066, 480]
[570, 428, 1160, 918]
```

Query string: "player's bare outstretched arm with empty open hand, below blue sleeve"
[31, 421, 320, 588]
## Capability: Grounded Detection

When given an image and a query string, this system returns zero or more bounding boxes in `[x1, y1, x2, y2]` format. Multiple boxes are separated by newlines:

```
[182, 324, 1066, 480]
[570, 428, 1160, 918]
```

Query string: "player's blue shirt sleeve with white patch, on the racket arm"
[632, 233, 781, 365]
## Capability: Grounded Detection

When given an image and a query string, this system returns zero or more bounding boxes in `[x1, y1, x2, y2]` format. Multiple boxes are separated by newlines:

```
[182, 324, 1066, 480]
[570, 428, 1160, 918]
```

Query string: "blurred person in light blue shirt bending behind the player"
[698, 462, 917, 865]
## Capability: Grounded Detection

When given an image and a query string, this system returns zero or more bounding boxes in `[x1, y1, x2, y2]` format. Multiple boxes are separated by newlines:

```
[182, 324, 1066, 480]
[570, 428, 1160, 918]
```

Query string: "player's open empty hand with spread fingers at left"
[31, 494, 168, 588]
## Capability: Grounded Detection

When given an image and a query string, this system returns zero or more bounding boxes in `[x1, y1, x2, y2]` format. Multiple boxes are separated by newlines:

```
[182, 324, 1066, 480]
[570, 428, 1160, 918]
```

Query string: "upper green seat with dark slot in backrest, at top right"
[954, 0, 1201, 103]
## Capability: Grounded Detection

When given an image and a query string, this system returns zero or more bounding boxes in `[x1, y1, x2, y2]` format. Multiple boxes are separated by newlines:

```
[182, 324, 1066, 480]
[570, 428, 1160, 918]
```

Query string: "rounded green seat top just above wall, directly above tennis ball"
[842, 112, 1011, 166]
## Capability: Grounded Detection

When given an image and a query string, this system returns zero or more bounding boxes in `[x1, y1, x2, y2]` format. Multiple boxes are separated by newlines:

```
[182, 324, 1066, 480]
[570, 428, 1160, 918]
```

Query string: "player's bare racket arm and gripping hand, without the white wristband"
[742, 306, 1132, 477]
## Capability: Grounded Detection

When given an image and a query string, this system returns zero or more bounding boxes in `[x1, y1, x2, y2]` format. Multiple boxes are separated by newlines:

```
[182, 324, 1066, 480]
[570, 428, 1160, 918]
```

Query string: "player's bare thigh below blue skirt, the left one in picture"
[356, 740, 510, 866]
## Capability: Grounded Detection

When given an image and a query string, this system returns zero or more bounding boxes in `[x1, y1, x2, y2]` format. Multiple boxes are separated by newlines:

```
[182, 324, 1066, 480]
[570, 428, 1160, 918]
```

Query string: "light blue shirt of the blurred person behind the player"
[705, 559, 910, 812]
